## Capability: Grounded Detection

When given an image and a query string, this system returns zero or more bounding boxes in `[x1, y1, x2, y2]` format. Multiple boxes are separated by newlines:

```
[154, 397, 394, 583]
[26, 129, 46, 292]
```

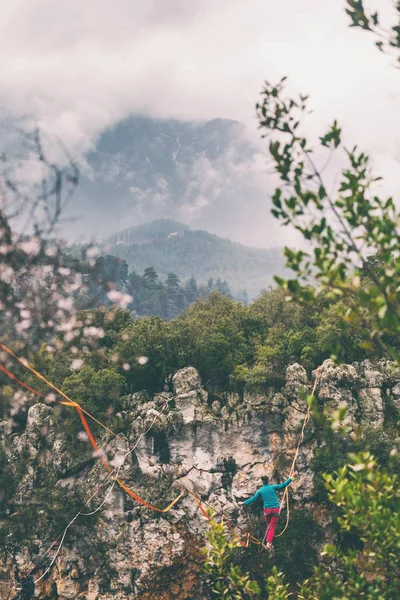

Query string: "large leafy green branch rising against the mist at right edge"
[257, 72, 400, 359]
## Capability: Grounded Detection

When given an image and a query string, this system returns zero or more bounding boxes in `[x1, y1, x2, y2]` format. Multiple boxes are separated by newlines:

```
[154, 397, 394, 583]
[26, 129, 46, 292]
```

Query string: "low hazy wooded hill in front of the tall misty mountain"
[104, 219, 284, 299]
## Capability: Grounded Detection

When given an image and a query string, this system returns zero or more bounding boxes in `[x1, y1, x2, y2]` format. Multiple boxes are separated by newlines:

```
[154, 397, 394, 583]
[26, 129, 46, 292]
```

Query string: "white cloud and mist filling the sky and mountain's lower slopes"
[0, 0, 400, 246]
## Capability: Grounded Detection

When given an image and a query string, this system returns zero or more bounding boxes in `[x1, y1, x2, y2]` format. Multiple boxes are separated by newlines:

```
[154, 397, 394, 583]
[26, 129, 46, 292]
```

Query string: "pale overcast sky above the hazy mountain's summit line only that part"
[0, 0, 400, 244]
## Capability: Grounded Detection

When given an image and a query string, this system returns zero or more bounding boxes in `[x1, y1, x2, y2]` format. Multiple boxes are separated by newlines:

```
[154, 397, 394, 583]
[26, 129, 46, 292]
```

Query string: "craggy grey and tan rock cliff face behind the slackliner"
[0, 361, 400, 600]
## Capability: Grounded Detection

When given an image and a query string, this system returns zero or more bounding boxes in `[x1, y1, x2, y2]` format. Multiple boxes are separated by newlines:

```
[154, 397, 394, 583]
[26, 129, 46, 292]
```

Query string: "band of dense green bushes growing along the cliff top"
[30, 278, 383, 406]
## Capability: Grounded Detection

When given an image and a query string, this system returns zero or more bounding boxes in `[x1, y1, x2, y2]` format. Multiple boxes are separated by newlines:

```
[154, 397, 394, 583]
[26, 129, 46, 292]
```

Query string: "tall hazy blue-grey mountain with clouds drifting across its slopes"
[69, 116, 264, 244]
